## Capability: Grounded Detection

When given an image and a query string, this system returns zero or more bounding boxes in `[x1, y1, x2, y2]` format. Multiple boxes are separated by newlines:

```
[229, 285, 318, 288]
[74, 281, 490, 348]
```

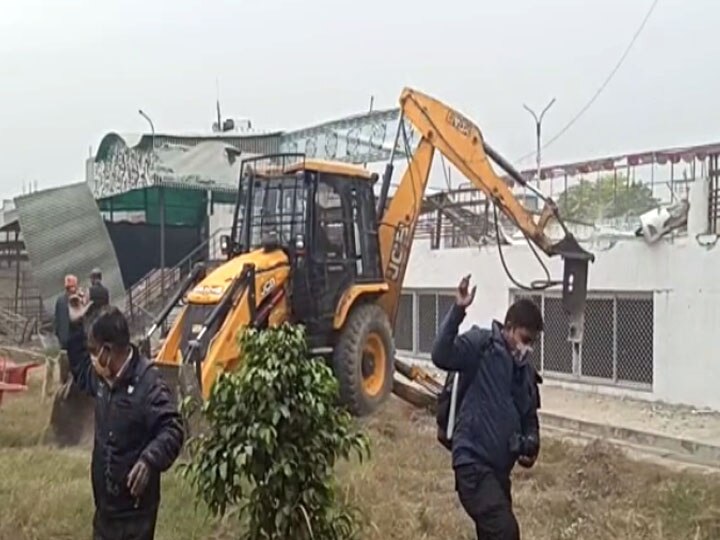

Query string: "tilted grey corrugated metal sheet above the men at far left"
[15, 182, 125, 312]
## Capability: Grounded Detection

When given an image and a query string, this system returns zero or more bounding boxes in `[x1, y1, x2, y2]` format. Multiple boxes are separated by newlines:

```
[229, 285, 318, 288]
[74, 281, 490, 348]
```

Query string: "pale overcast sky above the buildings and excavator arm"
[0, 0, 720, 197]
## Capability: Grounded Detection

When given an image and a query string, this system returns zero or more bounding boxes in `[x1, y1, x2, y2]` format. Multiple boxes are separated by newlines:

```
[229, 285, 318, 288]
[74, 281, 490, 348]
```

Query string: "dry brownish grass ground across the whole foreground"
[0, 370, 720, 540]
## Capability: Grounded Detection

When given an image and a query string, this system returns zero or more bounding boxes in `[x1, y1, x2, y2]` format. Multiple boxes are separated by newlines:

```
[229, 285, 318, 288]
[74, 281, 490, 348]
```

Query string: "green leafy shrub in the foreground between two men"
[183, 325, 369, 540]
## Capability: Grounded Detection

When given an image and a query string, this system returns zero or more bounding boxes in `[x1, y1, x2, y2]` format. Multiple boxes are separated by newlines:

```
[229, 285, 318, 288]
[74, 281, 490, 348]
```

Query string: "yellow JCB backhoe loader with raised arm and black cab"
[49, 89, 594, 442]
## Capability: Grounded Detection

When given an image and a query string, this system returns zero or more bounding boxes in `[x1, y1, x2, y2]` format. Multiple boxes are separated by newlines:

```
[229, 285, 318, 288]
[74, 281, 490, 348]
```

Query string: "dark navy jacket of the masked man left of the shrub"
[68, 325, 184, 517]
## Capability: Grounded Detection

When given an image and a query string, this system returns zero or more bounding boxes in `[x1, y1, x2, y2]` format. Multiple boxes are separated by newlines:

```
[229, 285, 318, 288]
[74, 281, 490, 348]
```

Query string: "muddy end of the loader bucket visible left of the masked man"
[45, 377, 95, 446]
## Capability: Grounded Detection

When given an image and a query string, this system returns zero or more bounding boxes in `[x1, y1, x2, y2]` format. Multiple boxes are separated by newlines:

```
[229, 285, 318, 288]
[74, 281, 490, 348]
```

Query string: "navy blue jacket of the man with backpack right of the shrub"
[432, 305, 540, 475]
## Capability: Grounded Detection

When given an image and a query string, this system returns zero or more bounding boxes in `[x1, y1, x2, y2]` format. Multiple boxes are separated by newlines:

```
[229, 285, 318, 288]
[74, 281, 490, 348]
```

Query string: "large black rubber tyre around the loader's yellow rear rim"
[333, 303, 395, 417]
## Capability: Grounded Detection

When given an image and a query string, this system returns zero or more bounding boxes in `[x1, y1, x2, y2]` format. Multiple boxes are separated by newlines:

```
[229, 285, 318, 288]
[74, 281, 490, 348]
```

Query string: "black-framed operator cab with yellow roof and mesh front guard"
[221, 154, 383, 346]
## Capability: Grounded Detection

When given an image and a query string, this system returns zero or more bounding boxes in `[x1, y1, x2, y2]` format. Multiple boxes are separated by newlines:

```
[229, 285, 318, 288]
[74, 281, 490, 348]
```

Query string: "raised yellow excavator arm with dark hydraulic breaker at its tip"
[378, 88, 594, 343]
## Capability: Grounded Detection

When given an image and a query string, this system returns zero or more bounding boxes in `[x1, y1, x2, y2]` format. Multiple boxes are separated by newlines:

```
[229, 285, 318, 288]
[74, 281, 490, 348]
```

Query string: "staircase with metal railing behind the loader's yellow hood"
[124, 229, 229, 333]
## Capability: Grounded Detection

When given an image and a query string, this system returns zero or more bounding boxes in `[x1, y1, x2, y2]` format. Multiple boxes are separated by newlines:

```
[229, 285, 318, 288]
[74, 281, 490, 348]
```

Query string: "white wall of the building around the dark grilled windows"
[405, 237, 720, 410]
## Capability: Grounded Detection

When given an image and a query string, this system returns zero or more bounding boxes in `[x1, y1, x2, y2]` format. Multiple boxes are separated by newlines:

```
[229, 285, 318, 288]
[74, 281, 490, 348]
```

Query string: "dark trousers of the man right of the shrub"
[455, 465, 520, 540]
